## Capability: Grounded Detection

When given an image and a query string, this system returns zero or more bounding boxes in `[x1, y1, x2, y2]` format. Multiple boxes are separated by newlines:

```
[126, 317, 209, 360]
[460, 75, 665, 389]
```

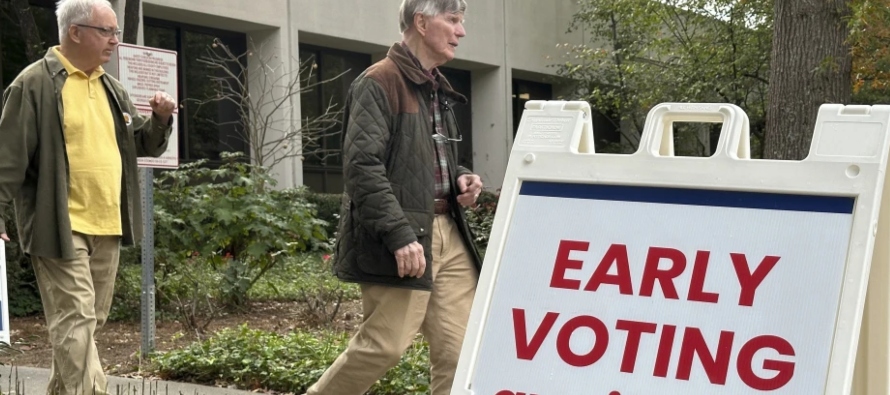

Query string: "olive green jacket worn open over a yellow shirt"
[0, 48, 172, 259]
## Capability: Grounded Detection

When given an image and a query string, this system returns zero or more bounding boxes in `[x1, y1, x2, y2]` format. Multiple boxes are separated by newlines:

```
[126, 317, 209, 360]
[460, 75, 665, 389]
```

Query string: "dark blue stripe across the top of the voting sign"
[519, 181, 856, 214]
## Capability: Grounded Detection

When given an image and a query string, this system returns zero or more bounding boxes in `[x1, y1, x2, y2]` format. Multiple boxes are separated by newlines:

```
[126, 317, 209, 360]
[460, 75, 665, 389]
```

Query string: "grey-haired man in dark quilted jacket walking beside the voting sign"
[307, 0, 482, 395]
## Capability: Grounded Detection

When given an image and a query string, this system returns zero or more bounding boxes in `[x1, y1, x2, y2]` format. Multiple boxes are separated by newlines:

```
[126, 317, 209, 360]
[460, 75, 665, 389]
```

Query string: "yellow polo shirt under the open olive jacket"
[53, 47, 123, 236]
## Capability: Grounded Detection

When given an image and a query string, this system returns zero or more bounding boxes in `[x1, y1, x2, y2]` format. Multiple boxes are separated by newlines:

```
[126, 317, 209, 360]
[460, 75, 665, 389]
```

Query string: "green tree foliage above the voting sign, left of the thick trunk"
[557, 0, 772, 151]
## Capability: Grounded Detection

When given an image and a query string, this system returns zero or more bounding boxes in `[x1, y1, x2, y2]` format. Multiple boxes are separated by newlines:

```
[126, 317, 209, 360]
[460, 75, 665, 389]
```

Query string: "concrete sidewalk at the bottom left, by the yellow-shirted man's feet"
[0, 366, 255, 395]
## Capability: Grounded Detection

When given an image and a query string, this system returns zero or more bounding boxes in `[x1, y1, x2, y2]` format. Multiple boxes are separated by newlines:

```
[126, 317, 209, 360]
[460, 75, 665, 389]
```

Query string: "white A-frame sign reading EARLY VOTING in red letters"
[452, 101, 890, 395]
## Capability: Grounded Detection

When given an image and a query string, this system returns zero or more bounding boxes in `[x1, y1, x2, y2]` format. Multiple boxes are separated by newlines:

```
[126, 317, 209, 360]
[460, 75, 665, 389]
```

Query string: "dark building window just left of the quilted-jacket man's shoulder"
[300, 44, 371, 193]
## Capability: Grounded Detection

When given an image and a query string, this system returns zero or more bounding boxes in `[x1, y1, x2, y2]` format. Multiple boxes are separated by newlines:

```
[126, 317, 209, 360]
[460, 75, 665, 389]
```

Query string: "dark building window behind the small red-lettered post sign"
[143, 17, 250, 164]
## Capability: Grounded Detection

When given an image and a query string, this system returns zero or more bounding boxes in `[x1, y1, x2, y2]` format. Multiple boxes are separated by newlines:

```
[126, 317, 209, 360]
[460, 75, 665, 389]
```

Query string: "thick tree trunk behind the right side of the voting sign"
[763, 0, 852, 160]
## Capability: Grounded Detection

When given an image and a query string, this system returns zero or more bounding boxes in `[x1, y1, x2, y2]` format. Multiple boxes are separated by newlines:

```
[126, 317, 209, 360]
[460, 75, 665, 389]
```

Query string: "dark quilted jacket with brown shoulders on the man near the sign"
[333, 43, 481, 290]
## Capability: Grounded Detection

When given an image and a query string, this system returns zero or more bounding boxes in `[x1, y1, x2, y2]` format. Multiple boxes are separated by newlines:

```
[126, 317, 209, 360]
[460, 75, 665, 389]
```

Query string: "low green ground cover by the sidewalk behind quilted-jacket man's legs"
[154, 325, 429, 395]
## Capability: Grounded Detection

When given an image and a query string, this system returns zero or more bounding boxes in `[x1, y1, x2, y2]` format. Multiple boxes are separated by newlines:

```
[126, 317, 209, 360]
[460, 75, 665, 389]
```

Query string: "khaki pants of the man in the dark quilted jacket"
[307, 215, 478, 395]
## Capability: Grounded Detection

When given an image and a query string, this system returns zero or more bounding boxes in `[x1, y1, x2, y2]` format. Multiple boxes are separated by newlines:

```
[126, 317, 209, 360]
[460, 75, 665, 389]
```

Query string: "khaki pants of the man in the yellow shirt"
[32, 233, 120, 395]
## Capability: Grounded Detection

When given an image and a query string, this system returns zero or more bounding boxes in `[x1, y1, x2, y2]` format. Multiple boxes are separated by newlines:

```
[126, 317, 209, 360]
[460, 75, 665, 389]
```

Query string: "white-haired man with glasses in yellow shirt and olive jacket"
[0, 0, 176, 395]
